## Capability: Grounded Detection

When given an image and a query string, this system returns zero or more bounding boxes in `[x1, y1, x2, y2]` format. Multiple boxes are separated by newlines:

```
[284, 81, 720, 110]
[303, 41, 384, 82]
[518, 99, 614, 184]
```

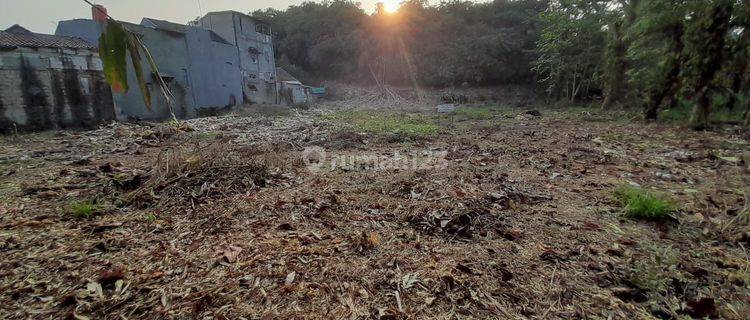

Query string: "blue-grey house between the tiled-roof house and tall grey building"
[55, 7, 244, 121]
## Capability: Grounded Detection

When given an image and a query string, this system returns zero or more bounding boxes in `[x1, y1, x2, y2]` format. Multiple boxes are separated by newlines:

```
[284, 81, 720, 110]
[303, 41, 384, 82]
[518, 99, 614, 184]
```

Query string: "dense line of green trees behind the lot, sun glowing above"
[251, 0, 750, 128]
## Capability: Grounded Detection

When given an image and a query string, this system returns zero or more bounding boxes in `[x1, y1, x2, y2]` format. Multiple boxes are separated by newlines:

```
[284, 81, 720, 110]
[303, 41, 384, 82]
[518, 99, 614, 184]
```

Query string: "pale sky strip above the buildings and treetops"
[0, 0, 394, 34]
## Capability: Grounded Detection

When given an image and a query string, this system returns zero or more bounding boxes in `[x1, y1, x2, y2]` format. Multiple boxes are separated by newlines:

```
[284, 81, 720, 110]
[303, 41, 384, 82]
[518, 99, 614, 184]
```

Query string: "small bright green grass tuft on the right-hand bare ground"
[614, 187, 677, 220]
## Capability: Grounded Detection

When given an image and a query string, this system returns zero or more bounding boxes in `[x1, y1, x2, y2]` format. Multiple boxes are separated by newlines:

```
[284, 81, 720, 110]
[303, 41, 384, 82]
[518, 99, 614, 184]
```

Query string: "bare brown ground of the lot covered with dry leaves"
[0, 99, 750, 319]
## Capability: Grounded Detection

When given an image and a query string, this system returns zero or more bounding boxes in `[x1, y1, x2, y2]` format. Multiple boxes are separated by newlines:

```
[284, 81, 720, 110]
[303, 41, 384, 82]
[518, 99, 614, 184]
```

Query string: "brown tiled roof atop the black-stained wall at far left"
[0, 31, 97, 50]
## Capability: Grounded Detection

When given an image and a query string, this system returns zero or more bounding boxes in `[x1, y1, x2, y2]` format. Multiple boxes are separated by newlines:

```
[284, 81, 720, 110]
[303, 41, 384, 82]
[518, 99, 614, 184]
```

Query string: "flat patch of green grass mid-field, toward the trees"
[323, 111, 442, 138]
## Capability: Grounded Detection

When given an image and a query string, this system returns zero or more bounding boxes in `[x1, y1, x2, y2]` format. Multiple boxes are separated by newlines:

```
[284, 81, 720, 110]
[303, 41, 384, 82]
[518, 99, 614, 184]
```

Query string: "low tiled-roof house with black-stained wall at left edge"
[0, 25, 115, 132]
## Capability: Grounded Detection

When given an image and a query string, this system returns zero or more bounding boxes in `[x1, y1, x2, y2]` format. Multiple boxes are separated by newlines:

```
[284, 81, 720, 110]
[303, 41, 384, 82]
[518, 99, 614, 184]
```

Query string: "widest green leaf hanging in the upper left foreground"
[99, 22, 128, 93]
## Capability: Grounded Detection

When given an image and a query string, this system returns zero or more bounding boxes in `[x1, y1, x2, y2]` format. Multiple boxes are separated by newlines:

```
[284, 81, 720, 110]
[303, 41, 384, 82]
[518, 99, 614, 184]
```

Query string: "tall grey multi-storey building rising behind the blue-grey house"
[198, 11, 279, 103]
